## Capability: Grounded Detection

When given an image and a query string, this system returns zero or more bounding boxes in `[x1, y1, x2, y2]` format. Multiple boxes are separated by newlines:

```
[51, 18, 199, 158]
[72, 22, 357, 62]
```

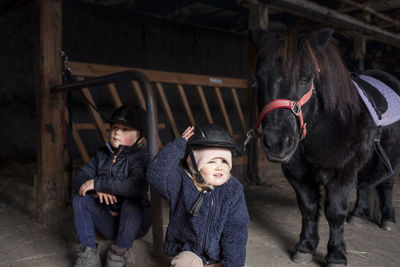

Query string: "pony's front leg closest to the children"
[289, 179, 320, 263]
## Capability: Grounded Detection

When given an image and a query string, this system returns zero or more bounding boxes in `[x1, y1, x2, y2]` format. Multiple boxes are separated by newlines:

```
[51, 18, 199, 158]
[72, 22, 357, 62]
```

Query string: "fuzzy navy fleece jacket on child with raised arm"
[147, 138, 249, 267]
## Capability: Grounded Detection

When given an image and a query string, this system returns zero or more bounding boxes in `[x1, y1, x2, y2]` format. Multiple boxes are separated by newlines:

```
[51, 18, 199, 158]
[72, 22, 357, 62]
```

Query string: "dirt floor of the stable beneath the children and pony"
[0, 162, 400, 267]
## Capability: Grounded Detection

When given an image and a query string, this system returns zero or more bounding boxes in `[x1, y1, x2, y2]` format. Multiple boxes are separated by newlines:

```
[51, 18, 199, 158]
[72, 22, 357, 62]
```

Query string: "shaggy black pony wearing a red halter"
[250, 26, 400, 266]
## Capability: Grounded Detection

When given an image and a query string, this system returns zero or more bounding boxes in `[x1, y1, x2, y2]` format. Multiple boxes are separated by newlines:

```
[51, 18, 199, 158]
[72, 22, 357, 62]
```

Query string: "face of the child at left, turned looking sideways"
[110, 123, 140, 148]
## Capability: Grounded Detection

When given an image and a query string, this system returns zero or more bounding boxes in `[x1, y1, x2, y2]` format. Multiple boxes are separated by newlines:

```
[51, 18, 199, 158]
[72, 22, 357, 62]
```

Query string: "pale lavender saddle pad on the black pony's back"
[353, 75, 400, 126]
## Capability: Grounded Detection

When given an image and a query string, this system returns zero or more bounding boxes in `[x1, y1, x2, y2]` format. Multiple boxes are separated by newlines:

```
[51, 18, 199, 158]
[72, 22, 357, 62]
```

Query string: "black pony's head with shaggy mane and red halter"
[250, 28, 356, 163]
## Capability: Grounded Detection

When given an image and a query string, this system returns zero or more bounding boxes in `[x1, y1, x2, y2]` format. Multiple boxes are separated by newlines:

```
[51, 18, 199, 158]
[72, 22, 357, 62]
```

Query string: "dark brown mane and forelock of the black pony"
[264, 29, 360, 114]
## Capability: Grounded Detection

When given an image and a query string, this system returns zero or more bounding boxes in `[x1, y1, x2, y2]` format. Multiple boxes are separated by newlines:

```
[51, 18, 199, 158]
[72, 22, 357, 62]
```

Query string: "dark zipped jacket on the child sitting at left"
[74, 143, 149, 211]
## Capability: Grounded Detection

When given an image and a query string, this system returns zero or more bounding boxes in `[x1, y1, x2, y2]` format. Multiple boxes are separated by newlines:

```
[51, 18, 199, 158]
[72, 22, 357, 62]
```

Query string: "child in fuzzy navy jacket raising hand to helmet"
[147, 124, 249, 267]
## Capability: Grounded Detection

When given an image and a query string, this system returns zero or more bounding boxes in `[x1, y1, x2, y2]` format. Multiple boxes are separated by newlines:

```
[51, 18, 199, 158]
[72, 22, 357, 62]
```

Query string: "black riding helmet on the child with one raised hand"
[188, 123, 238, 150]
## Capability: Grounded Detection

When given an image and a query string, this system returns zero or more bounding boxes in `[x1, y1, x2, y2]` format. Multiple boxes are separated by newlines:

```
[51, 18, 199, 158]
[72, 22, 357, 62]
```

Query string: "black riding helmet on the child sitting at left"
[109, 105, 147, 136]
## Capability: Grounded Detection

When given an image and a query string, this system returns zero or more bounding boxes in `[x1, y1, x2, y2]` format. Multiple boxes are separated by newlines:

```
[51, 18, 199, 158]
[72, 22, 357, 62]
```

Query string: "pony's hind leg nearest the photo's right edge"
[376, 175, 396, 231]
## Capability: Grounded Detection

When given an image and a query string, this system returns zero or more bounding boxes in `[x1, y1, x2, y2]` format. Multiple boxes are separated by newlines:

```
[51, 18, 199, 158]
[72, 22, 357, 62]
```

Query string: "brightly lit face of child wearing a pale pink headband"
[200, 157, 231, 186]
